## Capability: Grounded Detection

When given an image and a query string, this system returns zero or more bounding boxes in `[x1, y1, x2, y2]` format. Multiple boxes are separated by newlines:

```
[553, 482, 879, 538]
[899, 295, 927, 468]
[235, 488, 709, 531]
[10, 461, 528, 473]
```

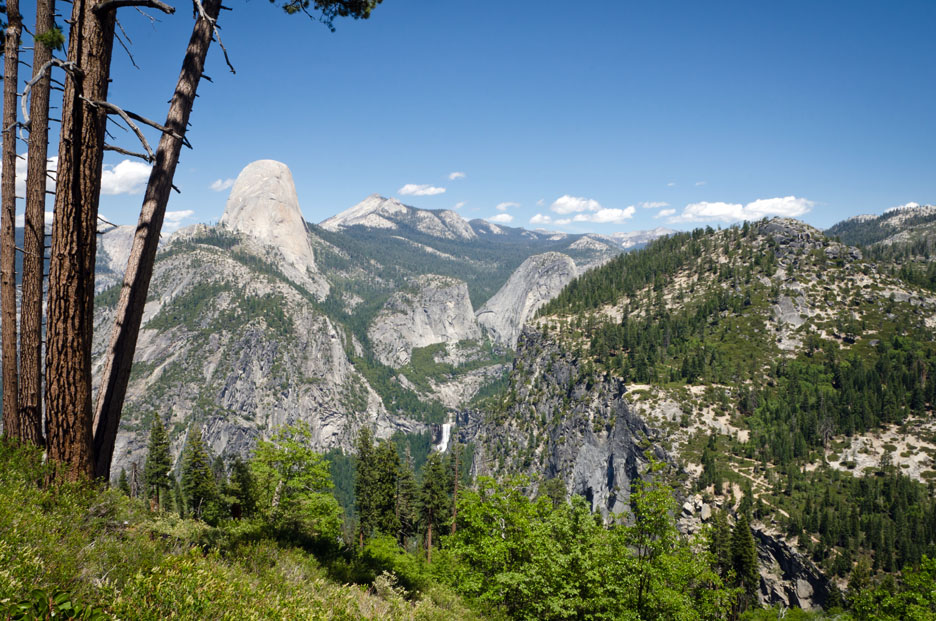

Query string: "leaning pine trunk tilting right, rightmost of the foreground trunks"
[94, 0, 221, 479]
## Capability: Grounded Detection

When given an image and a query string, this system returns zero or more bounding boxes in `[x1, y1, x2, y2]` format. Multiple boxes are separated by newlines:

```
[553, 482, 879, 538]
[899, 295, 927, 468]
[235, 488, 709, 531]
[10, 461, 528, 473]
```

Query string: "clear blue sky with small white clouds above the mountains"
[56, 0, 936, 232]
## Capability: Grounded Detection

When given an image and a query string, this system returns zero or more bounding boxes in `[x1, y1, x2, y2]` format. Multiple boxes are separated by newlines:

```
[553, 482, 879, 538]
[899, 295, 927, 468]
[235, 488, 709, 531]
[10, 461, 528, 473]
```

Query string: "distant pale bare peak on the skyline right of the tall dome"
[319, 194, 477, 240]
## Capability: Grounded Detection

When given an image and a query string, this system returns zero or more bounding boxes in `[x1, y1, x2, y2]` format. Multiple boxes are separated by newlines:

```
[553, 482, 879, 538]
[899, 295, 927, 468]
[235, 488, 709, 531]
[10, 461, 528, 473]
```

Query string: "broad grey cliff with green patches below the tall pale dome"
[95, 240, 424, 476]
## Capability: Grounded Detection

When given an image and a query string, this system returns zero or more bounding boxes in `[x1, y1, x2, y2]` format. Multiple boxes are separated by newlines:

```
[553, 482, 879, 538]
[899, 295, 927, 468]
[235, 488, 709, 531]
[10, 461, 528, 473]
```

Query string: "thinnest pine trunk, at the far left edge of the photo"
[0, 0, 23, 439]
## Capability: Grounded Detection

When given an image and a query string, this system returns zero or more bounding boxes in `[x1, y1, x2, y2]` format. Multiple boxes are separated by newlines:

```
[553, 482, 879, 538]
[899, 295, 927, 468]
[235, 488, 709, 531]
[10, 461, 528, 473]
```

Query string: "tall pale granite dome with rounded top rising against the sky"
[219, 160, 328, 298]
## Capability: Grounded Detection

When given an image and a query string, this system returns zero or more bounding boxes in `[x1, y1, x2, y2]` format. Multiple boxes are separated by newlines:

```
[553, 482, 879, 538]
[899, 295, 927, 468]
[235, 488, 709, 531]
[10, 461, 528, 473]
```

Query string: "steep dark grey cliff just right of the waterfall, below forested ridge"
[468, 328, 671, 518]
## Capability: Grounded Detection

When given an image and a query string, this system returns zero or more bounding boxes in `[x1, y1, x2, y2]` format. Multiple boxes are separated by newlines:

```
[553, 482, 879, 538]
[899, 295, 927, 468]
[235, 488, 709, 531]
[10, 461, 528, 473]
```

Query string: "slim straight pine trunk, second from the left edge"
[19, 0, 55, 446]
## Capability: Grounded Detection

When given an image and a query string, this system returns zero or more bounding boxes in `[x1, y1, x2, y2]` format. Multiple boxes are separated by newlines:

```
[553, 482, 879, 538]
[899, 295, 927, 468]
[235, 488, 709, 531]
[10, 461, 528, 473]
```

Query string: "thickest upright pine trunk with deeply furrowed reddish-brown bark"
[45, 0, 116, 479]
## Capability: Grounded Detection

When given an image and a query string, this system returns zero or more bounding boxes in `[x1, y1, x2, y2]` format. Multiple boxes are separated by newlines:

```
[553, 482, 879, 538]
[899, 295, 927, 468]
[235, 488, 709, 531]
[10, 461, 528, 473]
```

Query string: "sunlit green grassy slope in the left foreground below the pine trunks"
[0, 441, 475, 620]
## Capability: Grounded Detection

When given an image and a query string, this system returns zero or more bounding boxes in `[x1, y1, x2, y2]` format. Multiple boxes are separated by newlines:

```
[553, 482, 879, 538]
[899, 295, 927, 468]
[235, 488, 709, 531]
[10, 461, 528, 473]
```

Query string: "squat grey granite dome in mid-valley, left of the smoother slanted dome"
[367, 274, 481, 367]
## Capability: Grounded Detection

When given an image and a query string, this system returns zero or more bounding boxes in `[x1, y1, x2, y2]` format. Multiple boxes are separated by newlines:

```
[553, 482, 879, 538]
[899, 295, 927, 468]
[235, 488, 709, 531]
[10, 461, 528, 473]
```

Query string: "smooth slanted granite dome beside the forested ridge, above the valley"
[477, 252, 578, 347]
